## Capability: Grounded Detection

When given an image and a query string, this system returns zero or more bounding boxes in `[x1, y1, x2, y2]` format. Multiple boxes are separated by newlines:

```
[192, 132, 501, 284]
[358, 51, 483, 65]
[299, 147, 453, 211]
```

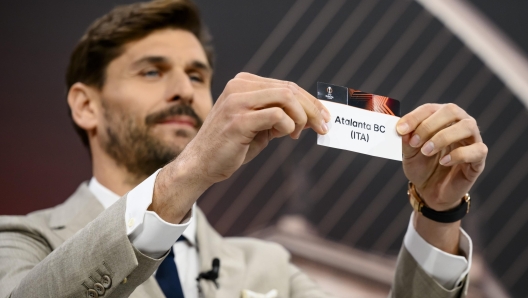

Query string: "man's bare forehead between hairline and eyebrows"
[117, 29, 209, 65]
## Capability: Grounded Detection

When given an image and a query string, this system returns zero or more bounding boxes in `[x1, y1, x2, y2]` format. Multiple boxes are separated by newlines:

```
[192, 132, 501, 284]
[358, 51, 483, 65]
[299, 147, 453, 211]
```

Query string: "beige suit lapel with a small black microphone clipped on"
[196, 209, 246, 298]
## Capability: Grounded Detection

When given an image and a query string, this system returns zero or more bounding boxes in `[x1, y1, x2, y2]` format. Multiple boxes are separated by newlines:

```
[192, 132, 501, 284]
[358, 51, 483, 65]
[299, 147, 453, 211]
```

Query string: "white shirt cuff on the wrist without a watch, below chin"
[125, 170, 194, 258]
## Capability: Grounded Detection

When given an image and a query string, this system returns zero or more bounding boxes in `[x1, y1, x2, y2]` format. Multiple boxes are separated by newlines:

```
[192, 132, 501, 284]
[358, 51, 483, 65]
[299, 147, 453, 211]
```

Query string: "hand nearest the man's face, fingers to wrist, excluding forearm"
[186, 73, 330, 184]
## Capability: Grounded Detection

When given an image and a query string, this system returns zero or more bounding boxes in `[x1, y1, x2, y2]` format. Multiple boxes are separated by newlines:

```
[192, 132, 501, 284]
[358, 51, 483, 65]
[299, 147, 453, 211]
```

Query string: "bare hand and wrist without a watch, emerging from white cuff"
[150, 73, 330, 223]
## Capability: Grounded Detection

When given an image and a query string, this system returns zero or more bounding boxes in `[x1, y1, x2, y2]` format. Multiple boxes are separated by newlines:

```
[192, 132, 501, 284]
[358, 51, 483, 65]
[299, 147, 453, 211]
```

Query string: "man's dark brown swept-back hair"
[66, 0, 214, 148]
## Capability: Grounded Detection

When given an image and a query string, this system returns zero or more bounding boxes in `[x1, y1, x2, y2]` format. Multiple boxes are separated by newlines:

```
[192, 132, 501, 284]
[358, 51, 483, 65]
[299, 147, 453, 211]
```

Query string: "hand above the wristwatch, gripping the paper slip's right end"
[397, 104, 488, 211]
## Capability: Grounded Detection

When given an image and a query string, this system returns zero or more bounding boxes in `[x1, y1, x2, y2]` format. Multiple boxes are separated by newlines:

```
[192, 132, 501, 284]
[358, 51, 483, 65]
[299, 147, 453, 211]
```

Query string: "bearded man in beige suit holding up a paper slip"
[0, 0, 487, 297]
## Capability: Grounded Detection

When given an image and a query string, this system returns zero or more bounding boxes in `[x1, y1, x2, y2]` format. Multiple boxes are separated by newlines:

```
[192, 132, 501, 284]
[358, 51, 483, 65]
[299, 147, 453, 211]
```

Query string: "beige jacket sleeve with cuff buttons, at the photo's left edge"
[0, 197, 166, 298]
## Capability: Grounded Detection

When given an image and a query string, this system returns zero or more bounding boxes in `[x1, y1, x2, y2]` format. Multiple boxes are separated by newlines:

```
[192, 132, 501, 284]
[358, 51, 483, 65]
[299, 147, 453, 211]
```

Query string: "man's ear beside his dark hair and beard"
[68, 82, 99, 131]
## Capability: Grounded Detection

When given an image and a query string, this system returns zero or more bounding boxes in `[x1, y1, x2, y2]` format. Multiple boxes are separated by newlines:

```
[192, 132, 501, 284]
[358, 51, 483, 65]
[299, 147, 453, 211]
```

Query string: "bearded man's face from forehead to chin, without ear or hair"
[97, 29, 213, 178]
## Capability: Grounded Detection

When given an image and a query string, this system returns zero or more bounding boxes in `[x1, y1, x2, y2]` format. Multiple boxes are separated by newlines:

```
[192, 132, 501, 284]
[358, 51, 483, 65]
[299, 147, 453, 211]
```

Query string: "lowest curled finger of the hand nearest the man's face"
[238, 107, 295, 144]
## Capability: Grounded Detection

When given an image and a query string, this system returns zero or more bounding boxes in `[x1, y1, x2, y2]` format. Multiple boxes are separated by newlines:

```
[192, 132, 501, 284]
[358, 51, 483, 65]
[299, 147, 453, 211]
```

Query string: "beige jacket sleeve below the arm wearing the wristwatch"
[389, 245, 469, 298]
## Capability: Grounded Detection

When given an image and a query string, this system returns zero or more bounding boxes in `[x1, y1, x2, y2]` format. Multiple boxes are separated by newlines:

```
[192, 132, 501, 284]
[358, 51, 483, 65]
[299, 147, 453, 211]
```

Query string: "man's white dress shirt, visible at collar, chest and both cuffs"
[89, 170, 473, 298]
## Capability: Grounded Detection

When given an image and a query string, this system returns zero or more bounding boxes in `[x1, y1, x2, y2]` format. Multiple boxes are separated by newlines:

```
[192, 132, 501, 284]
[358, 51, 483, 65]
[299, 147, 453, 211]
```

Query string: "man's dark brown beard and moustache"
[103, 100, 203, 180]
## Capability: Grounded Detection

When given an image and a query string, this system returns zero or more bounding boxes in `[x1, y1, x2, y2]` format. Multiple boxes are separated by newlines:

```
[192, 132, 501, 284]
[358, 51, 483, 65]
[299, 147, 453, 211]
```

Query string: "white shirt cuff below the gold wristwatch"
[403, 212, 473, 290]
